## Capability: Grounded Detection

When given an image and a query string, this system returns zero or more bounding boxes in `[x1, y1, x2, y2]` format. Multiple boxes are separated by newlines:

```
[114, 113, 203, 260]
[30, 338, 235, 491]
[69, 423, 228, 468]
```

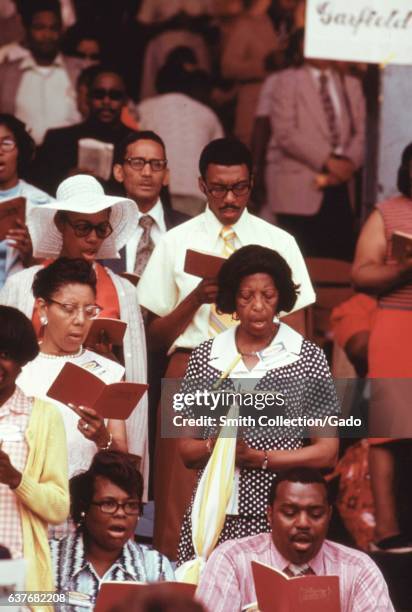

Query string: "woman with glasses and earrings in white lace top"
[19, 258, 127, 477]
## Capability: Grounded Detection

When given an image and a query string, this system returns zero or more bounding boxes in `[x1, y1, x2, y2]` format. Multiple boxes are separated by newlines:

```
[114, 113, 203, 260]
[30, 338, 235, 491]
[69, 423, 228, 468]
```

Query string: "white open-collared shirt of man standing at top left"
[15, 54, 81, 145]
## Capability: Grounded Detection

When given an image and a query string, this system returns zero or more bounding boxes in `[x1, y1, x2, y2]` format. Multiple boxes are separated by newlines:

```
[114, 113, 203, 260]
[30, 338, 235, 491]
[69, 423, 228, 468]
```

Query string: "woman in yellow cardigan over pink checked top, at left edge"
[0, 306, 69, 591]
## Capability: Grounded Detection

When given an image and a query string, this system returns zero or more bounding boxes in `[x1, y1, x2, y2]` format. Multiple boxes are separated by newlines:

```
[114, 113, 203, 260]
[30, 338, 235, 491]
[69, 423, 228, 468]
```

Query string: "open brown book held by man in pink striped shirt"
[252, 561, 341, 612]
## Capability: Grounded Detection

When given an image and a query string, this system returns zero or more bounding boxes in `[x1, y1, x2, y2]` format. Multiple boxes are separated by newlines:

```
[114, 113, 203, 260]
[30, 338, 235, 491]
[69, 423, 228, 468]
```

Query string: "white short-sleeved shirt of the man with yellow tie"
[137, 208, 315, 352]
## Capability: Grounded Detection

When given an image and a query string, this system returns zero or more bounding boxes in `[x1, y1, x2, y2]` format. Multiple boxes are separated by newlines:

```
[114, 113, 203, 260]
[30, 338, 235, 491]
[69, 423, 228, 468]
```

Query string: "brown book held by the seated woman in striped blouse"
[94, 581, 196, 612]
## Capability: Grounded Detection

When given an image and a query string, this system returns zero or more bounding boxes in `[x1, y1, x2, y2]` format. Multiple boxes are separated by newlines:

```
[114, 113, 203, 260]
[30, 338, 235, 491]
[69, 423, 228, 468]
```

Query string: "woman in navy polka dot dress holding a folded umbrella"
[178, 245, 339, 565]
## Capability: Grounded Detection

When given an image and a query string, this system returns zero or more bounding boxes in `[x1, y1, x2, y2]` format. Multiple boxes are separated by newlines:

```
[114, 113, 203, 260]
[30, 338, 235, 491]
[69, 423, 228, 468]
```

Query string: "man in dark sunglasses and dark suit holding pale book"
[33, 66, 133, 193]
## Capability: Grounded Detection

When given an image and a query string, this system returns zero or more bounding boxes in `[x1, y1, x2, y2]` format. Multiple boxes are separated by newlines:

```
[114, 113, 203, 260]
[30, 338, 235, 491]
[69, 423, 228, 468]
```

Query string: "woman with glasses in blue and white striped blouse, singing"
[50, 452, 174, 608]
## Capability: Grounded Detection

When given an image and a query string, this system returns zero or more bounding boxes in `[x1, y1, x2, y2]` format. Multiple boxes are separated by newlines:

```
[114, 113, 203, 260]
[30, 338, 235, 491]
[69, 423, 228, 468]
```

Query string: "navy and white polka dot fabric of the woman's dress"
[178, 339, 339, 565]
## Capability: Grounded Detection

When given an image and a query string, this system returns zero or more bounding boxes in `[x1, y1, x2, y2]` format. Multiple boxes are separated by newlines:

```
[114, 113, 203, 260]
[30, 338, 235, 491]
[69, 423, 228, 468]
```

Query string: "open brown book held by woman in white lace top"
[47, 362, 149, 420]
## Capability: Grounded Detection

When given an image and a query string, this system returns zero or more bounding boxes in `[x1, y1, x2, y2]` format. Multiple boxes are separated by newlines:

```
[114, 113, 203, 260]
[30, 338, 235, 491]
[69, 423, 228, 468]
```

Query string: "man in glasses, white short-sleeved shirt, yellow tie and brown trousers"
[138, 138, 315, 558]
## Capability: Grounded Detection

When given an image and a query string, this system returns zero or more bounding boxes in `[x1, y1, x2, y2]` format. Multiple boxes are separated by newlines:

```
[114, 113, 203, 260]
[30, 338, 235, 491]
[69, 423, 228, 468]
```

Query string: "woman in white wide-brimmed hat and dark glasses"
[0, 174, 149, 498]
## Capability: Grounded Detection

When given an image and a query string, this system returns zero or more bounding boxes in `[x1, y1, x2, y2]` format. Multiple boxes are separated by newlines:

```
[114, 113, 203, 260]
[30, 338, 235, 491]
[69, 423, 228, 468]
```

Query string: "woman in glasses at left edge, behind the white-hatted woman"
[0, 114, 51, 287]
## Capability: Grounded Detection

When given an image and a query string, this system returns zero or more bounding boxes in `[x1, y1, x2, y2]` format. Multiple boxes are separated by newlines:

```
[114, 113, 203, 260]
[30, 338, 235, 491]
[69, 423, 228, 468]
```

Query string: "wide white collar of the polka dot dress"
[209, 322, 303, 373]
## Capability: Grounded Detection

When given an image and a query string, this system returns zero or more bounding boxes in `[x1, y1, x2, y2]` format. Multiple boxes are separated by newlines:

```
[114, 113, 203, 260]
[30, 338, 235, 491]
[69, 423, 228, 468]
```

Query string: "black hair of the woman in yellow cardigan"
[0, 306, 39, 366]
